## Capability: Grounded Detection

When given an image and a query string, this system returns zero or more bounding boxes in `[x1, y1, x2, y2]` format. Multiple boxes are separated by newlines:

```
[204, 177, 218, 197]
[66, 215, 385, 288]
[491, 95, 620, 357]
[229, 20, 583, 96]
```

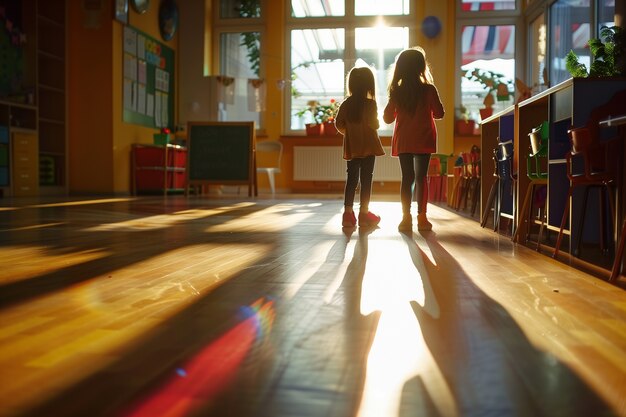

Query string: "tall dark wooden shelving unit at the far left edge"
[0, 0, 67, 196]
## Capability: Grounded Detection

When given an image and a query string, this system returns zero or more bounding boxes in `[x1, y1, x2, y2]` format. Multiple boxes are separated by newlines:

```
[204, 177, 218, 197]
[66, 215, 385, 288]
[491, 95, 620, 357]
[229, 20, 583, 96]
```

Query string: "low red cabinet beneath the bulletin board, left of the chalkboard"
[131, 144, 187, 195]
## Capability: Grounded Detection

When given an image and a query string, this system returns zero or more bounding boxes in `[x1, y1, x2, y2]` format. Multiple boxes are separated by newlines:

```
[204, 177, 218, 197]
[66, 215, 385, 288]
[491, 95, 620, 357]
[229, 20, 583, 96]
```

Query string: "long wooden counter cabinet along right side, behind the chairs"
[481, 78, 626, 264]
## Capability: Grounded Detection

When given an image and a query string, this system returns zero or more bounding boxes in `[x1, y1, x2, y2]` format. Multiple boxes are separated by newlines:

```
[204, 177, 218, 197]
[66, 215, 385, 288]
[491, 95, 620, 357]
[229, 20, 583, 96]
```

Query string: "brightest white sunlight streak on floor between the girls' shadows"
[358, 237, 458, 417]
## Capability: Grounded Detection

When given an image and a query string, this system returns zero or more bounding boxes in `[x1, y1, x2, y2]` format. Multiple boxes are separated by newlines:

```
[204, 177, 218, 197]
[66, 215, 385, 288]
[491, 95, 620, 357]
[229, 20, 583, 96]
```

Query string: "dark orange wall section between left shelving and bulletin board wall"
[67, 0, 114, 193]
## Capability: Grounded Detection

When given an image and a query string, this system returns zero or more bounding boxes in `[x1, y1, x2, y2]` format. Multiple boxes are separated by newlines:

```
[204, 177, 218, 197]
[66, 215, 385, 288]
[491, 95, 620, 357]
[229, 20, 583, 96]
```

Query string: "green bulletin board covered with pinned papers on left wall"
[122, 25, 175, 129]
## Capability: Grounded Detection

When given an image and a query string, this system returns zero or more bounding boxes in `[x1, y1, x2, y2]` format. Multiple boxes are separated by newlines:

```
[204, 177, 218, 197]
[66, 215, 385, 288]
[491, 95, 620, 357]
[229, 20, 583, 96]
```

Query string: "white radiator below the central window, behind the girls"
[293, 146, 400, 181]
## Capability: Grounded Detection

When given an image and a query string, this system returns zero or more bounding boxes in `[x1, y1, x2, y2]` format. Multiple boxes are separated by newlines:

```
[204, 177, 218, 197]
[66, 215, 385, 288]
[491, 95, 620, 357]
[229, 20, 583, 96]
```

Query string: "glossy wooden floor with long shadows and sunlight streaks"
[0, 196, 626, 417]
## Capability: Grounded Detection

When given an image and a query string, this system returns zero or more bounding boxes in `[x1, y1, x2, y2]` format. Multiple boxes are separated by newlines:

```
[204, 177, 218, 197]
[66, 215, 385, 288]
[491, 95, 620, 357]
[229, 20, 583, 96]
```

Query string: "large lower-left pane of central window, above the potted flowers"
[291, 29, 345, 129]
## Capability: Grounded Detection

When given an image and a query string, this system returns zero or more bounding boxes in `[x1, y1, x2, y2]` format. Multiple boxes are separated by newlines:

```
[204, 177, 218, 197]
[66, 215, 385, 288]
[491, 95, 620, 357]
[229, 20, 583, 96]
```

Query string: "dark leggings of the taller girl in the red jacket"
[398, 153, 430, 214]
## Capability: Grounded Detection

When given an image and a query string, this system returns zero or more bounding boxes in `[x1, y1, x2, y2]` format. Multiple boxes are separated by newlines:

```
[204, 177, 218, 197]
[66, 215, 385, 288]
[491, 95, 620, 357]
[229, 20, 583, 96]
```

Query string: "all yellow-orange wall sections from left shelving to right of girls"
[68, 0, 455, 194]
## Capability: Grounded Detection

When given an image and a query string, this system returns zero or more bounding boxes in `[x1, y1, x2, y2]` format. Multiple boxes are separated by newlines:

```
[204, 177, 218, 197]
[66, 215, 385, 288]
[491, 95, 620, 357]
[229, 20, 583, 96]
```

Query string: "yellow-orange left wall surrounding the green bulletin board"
[68, 0, 179, 194]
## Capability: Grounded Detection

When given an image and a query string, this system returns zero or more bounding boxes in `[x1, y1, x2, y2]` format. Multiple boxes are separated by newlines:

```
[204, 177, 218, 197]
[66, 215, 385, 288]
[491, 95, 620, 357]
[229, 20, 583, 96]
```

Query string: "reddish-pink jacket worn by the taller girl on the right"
[383, 84, 445, 156]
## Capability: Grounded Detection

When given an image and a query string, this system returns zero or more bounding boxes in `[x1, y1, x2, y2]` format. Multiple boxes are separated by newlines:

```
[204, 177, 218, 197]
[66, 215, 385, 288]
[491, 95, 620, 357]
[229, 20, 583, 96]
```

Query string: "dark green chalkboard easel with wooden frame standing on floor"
[185, 122, 258, 196]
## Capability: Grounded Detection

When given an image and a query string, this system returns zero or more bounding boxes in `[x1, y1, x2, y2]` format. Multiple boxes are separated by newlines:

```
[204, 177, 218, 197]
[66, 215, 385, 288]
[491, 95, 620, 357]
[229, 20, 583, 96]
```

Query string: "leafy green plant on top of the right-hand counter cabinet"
[565, 26, 626, 78]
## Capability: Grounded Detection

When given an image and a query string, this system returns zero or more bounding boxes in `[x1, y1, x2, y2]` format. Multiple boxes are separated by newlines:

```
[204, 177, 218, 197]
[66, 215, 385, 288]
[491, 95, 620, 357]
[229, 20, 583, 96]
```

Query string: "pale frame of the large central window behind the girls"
[282, 0, 414, 135]
